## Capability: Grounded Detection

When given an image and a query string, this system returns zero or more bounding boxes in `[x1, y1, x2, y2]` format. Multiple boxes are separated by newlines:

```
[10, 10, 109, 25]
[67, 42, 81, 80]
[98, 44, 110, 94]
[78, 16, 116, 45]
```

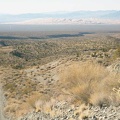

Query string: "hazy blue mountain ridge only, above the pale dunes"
[0, 10, 120, 24]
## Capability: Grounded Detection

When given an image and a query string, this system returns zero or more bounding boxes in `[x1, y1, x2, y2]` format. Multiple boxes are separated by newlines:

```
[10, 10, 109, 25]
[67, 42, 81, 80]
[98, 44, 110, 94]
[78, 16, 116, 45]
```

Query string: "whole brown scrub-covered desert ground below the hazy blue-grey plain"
[0, 25, 120, 120]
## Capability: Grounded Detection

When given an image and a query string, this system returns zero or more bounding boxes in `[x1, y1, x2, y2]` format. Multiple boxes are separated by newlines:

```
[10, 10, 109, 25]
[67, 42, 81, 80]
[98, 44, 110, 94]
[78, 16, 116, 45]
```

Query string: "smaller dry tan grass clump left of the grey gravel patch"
[15, 92, 51, 117]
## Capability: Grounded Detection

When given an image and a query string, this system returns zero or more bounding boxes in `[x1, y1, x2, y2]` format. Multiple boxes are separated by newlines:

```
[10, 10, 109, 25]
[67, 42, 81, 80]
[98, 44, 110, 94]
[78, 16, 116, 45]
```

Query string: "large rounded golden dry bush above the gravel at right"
[61, 62, 120, 105]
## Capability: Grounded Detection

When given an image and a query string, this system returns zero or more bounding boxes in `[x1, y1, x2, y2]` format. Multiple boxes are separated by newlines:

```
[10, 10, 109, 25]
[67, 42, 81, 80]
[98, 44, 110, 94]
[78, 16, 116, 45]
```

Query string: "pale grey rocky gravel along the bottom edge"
[18, 106, 120, 120]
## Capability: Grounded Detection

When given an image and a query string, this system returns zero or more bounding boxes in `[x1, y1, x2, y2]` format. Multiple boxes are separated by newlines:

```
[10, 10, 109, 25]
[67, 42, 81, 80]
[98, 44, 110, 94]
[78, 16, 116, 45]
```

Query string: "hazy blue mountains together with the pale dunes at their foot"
[0, 10, 120, 24]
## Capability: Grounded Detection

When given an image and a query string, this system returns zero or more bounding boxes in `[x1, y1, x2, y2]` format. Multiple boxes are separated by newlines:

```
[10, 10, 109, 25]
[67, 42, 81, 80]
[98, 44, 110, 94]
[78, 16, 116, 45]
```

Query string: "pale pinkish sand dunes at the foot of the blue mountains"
[7, 18, 120, 25]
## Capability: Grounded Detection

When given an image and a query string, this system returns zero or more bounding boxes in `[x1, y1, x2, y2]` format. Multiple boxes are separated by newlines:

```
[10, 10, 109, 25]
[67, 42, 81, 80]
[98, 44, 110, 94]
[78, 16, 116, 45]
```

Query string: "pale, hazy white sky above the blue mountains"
[0, 0, 120, 14]
